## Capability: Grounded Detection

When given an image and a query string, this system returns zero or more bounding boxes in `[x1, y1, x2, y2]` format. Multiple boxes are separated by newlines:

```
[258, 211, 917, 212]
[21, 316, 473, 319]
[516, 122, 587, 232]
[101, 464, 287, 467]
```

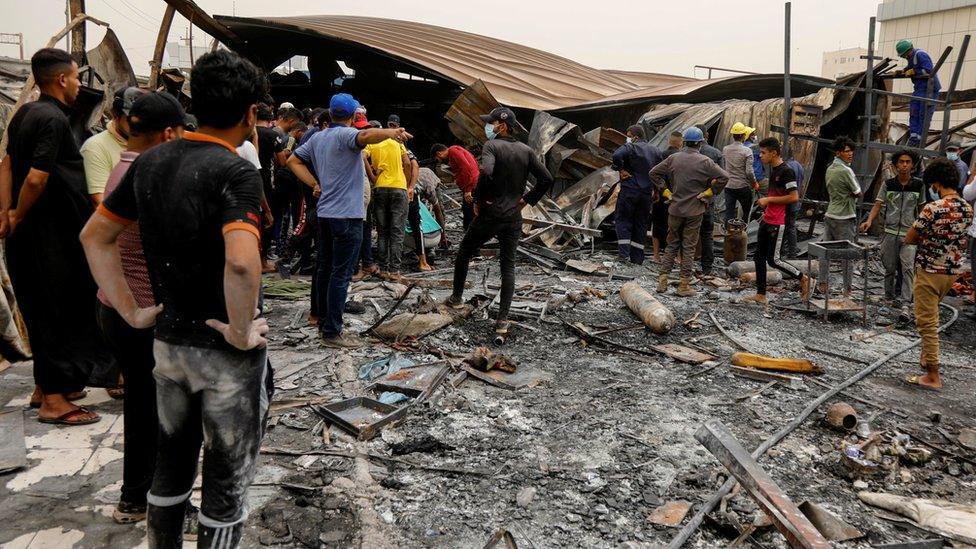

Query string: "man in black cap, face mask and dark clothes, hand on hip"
[447, 107, 552, 335]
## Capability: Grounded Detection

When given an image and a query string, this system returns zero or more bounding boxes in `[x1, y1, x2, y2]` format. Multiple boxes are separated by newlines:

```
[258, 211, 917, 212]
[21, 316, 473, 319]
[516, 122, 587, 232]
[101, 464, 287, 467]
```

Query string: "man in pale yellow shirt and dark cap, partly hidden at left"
[81, 86, 146, 206]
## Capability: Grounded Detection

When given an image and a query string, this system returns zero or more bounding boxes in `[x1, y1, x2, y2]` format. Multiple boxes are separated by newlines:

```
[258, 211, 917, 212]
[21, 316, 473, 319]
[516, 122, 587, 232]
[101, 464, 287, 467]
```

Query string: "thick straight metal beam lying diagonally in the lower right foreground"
[695, 419, 830, 549]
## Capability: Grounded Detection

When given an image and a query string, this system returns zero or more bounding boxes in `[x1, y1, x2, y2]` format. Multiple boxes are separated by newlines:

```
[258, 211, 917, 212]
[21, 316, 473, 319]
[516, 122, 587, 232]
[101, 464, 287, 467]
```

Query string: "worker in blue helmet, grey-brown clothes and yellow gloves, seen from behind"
[649, 127, 729, 297]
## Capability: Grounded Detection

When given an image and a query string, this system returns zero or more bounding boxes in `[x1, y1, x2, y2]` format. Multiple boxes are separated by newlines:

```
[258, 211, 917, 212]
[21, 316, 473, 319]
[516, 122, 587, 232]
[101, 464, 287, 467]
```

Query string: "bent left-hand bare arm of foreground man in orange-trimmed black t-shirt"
[81, 212, 163, 329]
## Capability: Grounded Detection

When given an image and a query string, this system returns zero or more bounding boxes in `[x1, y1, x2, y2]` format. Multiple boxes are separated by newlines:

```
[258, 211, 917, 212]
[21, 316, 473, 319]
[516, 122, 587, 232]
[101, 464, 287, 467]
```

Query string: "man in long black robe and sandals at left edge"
[0, 48, 112, 425]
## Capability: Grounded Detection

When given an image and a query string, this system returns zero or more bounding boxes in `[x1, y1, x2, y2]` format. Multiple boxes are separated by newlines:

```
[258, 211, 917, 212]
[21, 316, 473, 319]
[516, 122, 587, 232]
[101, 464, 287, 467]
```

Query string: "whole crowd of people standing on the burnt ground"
[0, 40, 976, 547]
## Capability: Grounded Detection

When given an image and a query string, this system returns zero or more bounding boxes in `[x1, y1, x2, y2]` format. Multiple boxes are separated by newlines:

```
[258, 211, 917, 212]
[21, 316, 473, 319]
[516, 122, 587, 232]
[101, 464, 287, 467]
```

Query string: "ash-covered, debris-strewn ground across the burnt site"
[0, 223, 976, 549]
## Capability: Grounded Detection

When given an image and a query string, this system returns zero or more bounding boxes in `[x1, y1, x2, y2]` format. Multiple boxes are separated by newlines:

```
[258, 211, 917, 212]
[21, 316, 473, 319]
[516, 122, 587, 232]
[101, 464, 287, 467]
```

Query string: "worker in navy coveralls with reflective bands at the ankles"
[613, 125, 661, 265]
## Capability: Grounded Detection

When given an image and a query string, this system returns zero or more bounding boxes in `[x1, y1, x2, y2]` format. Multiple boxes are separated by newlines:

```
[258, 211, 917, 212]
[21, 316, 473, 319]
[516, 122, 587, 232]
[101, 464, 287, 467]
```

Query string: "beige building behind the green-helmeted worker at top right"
[877, 0, 976, 128]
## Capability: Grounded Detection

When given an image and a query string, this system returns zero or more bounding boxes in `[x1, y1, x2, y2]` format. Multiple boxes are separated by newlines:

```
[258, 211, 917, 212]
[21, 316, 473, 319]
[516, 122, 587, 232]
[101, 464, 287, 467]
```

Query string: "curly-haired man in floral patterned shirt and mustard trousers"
[905, 158, 973, 390]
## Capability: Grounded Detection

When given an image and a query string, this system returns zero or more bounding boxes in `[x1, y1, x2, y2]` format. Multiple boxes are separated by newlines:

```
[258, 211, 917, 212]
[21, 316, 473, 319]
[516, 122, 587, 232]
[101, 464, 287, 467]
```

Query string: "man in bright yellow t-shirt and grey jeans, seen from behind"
[365, 114, 410, 280]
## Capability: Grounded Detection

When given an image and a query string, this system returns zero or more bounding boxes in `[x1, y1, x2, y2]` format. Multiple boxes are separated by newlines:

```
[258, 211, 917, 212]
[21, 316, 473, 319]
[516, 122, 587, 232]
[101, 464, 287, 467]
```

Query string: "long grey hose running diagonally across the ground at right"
[668, 303, 959, 549]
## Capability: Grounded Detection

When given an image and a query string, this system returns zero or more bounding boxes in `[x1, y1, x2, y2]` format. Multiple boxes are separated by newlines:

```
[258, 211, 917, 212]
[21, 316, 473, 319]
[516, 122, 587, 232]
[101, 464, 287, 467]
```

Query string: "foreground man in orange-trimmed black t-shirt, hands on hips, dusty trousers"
[81, 50, 271, 547]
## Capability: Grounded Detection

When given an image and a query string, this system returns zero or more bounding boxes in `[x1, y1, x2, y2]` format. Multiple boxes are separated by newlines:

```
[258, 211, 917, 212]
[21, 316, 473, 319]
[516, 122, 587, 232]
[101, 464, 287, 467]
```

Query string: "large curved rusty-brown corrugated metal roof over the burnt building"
[215, 15, 637, 109]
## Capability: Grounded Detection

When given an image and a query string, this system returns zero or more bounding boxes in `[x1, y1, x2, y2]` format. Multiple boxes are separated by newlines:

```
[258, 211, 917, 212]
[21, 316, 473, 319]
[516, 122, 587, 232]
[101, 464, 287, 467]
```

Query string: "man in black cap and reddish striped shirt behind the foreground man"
[86, 92, 186, 524]
